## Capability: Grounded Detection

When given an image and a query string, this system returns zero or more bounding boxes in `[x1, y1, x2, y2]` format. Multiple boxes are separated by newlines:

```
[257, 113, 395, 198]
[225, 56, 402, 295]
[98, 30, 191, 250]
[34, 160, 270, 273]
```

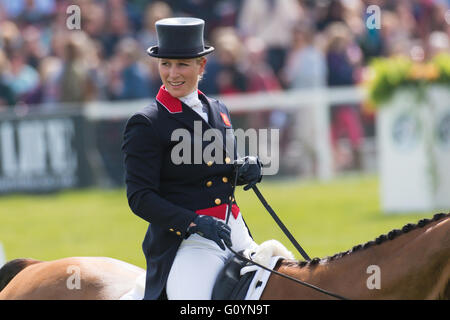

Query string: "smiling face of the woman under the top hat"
[158, 57, 206, 98]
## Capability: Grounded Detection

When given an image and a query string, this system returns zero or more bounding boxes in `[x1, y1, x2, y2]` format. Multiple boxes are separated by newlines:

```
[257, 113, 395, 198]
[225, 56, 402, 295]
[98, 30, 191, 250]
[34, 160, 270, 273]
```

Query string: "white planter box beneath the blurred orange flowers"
[377, 87, 450, 213]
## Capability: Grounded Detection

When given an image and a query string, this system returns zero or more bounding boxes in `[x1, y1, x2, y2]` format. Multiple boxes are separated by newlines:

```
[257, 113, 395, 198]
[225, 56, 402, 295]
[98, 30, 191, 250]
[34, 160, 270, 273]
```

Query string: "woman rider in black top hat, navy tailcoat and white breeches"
[122, 18, 262, 300]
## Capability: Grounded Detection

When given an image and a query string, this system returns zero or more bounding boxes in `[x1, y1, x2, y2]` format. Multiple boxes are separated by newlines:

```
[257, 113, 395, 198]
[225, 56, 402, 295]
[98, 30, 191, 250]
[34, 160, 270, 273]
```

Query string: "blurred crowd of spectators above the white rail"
[0, 0, 450, 108]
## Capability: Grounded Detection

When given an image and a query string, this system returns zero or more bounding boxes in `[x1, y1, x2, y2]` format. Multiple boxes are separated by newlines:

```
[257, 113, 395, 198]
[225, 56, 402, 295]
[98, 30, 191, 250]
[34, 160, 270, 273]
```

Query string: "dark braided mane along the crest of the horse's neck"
[288, 213, 450, 267]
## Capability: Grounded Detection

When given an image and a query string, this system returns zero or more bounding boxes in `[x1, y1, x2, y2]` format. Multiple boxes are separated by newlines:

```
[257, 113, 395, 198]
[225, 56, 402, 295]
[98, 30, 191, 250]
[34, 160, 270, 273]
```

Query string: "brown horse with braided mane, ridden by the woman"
[0, 213, 450, 300]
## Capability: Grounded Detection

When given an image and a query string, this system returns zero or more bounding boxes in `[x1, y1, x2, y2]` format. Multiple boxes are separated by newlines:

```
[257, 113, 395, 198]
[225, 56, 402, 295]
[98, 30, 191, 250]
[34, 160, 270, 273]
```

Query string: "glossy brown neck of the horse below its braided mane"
[279, 218, 450, 299]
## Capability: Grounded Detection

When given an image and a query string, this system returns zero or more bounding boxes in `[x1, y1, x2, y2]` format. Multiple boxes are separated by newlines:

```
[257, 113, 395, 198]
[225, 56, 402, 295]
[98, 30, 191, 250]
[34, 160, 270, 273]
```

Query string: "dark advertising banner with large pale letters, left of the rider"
[0, 113, 90, 194]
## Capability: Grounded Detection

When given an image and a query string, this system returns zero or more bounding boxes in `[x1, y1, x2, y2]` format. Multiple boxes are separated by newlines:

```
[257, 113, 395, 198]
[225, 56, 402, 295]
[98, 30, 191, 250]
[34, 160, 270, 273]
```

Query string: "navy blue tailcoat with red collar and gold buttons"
[122, 87, 243, 299]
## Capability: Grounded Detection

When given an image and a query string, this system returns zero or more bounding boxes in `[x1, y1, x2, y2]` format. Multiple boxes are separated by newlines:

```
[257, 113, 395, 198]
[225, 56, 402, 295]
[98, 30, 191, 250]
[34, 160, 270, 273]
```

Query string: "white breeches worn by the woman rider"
[166, 213, 257, 300]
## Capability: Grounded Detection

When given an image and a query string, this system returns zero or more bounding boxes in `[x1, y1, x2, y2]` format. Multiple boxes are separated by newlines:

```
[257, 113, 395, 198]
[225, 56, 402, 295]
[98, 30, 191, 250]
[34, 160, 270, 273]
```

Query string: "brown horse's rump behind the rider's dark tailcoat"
[0, 257, 145, 300]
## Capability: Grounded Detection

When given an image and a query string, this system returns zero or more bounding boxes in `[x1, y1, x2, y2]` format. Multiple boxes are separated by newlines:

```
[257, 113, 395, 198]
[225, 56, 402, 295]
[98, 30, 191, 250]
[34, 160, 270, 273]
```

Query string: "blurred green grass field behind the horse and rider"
[0, 176, 434, 267]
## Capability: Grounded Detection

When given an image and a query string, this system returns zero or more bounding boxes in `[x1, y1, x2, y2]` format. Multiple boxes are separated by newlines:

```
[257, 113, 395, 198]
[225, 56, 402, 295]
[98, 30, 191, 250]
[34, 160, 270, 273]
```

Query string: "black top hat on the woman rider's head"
[147, 18, 214, 59]
